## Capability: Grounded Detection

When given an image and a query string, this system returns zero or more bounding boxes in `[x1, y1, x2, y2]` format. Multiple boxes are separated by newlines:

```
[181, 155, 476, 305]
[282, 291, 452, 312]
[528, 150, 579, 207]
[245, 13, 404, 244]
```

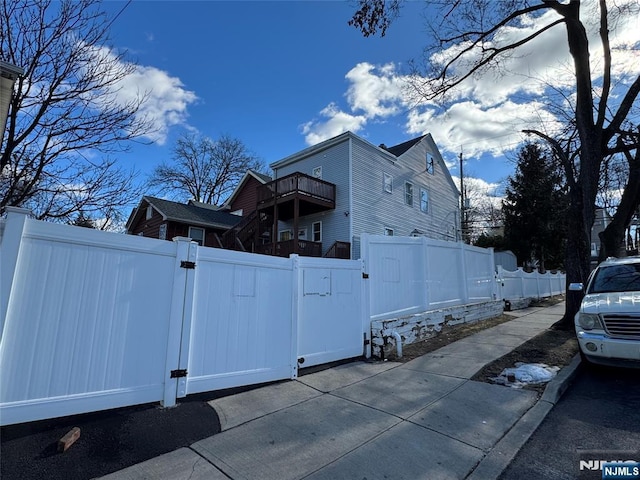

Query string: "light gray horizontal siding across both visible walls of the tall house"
[274, 131, 460, 258]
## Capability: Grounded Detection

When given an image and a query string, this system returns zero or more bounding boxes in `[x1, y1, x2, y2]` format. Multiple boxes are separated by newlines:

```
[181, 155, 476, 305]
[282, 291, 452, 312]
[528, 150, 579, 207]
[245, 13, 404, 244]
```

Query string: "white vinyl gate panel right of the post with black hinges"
[186, 248, 296, 393]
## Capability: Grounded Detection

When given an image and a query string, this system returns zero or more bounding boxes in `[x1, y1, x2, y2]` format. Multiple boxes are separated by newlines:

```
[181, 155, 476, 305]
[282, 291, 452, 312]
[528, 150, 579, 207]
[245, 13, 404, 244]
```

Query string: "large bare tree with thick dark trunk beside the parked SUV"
[351, 0, 640, 329]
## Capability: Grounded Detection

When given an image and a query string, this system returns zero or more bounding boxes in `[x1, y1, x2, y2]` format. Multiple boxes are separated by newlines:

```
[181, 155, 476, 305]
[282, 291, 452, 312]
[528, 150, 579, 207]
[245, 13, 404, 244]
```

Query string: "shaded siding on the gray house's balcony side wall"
[275, 139, 351, 255]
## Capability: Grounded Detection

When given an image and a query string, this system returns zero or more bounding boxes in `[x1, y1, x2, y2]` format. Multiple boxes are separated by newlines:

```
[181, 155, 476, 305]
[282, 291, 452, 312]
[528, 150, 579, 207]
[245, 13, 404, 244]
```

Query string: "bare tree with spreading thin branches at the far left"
[0, 0, 151, 225]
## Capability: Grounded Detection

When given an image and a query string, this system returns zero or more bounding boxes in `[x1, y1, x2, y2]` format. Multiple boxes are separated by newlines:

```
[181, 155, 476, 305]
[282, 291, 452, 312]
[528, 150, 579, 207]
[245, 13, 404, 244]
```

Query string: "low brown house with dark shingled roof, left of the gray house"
[126, 196, 242, 247]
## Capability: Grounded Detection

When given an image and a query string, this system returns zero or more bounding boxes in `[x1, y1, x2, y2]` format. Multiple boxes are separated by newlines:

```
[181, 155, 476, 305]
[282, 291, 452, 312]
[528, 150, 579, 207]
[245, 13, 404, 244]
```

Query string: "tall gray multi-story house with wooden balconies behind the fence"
[264, 132, 460, 258]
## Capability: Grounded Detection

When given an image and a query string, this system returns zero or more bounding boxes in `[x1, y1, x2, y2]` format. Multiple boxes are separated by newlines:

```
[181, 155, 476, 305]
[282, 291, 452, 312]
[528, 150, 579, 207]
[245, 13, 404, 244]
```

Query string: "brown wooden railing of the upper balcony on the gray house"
[257, 172, 336, 207]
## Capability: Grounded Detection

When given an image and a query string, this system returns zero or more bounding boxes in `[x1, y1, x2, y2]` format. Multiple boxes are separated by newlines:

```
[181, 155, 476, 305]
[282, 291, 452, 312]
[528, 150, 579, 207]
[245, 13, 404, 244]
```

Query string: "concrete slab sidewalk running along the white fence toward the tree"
[96, 303, 578, 480]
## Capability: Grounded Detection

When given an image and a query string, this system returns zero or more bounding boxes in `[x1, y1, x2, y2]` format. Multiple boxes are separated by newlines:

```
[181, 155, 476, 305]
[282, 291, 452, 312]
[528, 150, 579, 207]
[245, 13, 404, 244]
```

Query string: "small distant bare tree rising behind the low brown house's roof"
[148, 135, 264, 205]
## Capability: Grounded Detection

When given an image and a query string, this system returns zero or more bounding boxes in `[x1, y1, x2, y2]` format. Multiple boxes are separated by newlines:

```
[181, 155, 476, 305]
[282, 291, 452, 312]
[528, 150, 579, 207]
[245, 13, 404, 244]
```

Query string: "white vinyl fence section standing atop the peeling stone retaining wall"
[361, 234, 497, 320]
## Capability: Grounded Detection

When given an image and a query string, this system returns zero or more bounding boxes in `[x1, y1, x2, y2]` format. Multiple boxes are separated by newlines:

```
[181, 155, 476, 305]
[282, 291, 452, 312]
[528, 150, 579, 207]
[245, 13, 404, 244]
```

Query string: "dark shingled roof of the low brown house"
[127, 195, 242, 230]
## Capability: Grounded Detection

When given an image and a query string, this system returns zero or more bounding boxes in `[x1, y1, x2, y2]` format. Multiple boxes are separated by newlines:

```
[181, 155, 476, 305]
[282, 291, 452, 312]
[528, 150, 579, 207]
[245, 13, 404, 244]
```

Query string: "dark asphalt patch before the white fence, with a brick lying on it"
[0, 398, 220, 480]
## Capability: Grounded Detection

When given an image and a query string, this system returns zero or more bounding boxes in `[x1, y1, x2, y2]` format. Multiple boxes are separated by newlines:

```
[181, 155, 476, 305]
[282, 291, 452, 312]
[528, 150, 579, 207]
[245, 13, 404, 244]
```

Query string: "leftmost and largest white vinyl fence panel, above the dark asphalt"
[0, 219, 177, 424]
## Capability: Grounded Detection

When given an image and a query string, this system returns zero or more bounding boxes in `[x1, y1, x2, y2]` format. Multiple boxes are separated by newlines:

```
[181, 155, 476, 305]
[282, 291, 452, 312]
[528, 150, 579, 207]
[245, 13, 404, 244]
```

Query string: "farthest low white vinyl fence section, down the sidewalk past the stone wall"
[497, 265, 567, 300]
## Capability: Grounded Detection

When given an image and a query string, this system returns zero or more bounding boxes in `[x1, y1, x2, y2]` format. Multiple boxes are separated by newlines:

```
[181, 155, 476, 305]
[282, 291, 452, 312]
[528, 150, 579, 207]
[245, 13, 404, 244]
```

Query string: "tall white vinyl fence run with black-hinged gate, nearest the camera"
[0, 208, 369, 425]
